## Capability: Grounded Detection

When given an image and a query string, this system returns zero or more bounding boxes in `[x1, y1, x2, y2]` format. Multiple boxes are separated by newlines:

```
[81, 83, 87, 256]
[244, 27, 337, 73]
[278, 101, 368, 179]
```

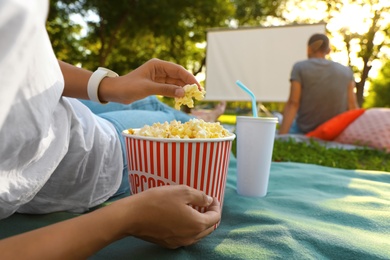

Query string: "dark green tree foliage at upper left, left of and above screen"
[47, 0, 286, 75]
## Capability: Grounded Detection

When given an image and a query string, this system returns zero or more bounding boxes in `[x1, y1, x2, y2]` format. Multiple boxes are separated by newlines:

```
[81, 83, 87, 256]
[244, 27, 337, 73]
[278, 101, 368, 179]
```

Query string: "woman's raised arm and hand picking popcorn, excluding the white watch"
[59, 59, 200, 104]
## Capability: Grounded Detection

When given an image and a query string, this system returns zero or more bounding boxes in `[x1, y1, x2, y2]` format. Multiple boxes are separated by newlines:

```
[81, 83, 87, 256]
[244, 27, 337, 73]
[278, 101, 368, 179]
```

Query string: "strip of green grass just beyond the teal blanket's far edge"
[232, 139, 390, 172]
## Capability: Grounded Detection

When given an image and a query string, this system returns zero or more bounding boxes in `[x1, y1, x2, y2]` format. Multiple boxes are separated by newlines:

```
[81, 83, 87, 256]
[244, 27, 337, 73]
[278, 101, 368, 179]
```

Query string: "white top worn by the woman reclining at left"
[0, 0, 123, 219]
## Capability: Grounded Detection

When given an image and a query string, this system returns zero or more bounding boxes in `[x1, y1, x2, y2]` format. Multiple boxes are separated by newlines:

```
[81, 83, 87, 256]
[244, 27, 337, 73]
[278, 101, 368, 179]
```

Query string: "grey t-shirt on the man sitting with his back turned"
[290, 58, 354, 133]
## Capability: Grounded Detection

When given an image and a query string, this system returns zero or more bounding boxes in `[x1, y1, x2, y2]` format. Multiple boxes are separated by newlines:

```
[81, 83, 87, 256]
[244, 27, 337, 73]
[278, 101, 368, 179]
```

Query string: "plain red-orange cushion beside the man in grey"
[306, 108, 365, 141]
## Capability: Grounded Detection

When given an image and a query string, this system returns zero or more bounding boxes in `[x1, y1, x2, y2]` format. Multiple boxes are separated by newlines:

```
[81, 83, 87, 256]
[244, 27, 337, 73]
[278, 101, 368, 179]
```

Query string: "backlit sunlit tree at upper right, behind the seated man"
[276, 0, 390, 105]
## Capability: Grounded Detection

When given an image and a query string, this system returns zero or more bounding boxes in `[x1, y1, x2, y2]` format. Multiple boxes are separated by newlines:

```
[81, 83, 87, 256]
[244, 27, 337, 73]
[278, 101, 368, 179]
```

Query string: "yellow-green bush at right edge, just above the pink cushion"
[364, 62, 390, 108]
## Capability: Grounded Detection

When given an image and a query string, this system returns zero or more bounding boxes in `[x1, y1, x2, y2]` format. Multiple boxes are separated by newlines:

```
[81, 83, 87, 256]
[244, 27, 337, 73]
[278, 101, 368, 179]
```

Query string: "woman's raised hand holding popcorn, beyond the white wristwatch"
[99, 59, 200, 104]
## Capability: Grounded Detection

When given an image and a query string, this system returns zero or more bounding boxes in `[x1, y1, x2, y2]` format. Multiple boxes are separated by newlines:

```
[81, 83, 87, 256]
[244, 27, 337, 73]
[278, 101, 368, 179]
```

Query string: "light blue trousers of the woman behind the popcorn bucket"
[80, 96, 193, 196]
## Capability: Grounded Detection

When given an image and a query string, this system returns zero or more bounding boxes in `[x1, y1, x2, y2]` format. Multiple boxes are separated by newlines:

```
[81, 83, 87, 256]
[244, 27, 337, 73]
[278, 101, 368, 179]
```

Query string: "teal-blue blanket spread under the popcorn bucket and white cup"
[0, 158, 390, 259]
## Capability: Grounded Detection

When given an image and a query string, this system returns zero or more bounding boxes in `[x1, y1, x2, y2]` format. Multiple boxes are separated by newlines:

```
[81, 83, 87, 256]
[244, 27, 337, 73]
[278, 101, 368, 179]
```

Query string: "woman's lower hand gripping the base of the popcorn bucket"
[117, 185, 221, 248]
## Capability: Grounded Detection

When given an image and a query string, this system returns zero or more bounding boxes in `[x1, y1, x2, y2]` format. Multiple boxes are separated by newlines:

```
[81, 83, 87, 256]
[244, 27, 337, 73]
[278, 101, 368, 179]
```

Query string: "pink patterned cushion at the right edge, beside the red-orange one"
[334, 108, 390, 152]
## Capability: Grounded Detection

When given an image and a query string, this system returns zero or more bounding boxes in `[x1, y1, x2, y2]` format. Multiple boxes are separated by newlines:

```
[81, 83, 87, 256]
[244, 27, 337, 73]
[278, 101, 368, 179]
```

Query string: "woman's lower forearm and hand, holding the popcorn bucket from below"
[0, 185, 221, 259]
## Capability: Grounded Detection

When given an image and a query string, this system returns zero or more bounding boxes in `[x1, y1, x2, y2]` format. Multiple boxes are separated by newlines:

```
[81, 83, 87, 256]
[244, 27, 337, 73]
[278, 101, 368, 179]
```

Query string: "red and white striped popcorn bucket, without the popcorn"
[122, 129, 235, 217]
